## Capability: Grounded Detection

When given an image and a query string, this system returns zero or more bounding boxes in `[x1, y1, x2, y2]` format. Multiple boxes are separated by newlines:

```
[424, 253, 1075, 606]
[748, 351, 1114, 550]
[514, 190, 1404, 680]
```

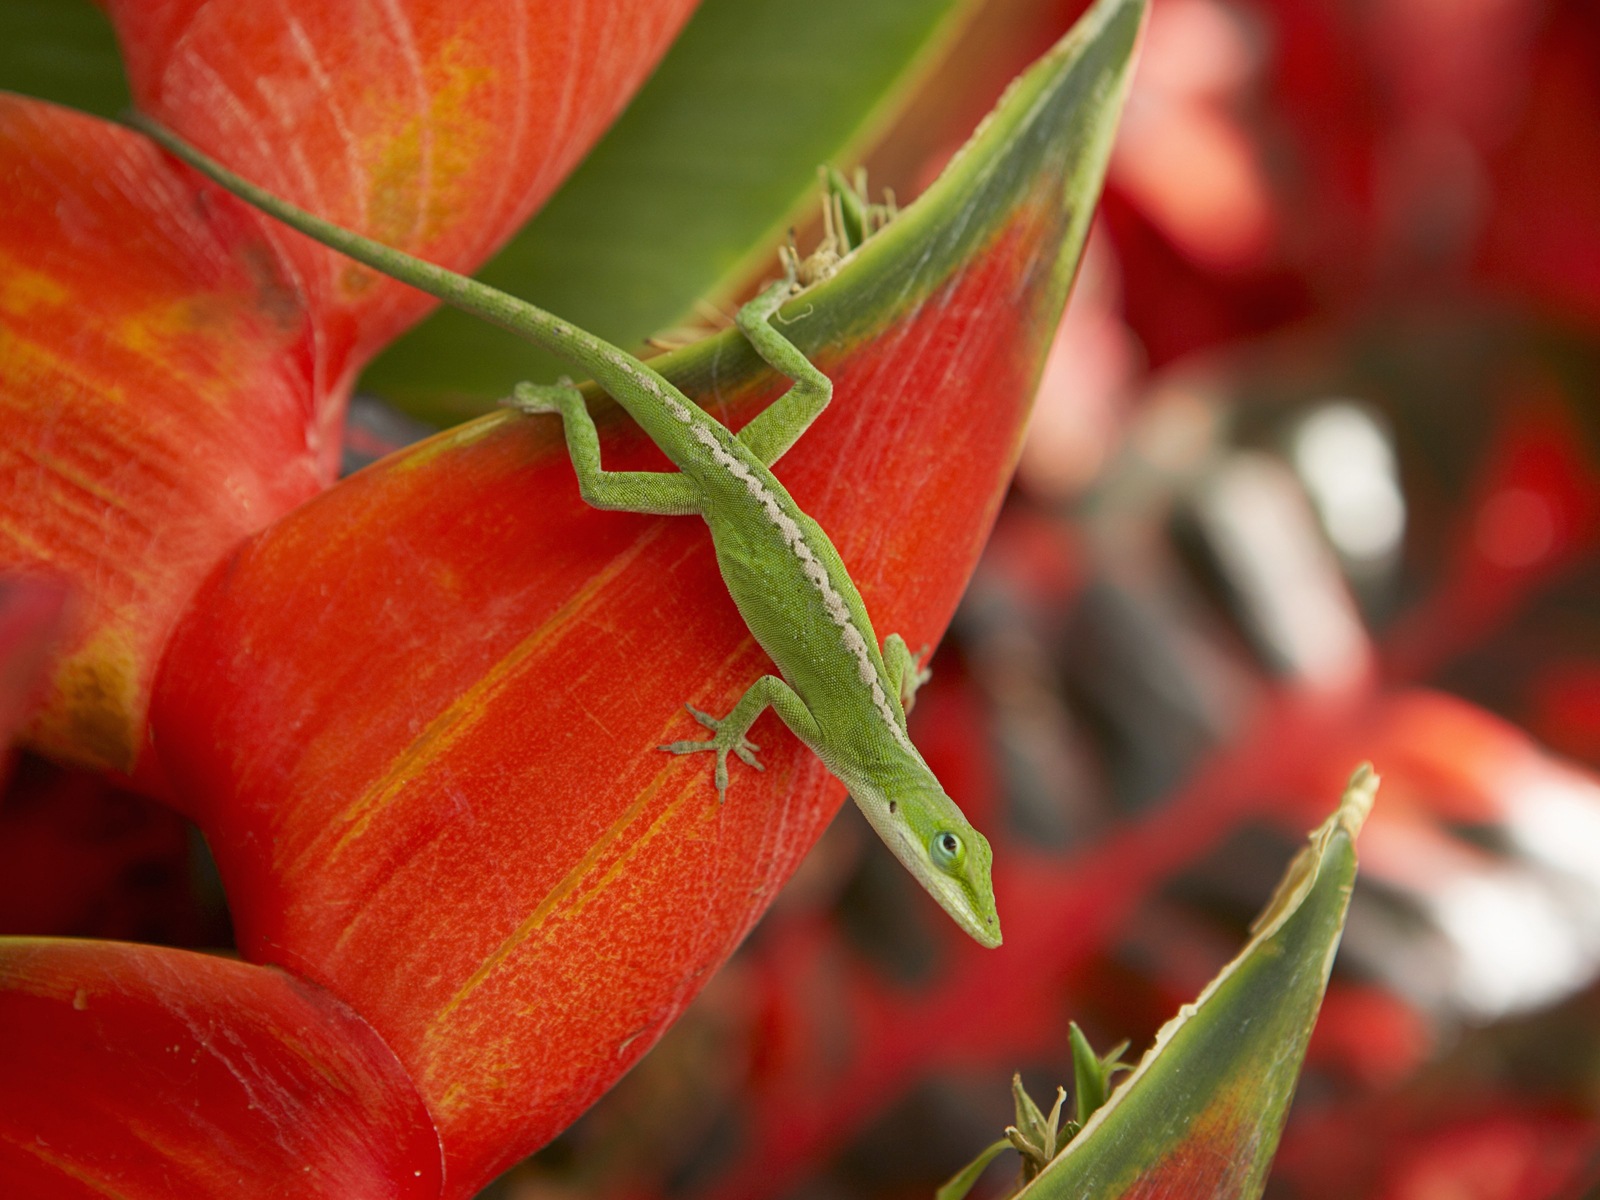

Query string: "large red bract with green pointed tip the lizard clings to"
[144, 5, 1138, 1186]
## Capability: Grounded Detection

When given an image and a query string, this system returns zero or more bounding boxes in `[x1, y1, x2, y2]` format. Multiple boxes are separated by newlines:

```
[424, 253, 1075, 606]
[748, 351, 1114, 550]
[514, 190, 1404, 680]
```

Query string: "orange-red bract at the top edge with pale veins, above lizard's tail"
[107, 0, 694, 384]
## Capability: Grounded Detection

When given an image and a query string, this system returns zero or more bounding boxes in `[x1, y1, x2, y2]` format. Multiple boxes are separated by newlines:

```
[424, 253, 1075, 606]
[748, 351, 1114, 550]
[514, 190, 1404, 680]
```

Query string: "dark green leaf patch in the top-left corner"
[0, 0, 130, 117]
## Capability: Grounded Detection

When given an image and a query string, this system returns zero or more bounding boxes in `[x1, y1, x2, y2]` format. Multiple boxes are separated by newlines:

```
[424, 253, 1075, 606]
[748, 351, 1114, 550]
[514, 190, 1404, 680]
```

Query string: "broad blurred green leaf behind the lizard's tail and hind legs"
[362, 0, 973, 421]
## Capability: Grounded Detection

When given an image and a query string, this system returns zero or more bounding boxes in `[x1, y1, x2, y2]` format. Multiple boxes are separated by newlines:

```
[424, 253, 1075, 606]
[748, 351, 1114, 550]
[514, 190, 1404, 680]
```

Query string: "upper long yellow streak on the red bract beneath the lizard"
[318, 526, 659, 870]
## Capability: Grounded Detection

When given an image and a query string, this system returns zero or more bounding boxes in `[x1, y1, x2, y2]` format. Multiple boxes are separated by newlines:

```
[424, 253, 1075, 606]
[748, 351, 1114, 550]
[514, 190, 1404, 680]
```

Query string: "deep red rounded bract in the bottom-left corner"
[0, 938, 440, 1200]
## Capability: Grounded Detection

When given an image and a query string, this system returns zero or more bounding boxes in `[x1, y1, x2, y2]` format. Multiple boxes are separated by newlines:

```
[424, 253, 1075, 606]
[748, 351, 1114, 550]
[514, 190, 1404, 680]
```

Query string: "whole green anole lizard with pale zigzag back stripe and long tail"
[133, 117, 1000, 947]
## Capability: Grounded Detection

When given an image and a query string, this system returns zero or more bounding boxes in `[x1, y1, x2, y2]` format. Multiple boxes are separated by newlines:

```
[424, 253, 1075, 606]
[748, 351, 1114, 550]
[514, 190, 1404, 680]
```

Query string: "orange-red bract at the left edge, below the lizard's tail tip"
[0, 96, 331, 770]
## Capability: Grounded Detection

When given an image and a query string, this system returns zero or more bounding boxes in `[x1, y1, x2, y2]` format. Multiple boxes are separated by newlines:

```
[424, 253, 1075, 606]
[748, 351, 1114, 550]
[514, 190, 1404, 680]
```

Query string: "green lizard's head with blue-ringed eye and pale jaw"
[851, 774, 1000, 949]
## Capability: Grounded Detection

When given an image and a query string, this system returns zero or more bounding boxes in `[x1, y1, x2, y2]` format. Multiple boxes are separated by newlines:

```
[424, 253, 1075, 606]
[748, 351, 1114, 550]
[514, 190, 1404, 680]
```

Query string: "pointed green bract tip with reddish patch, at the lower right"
[1019, 766, 1378, 1200]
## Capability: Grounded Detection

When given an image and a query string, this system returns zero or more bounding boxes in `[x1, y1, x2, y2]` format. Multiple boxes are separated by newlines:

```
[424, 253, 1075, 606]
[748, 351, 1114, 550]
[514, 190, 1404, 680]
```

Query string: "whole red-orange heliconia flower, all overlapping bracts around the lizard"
[0, 0, 1144, 1197]
